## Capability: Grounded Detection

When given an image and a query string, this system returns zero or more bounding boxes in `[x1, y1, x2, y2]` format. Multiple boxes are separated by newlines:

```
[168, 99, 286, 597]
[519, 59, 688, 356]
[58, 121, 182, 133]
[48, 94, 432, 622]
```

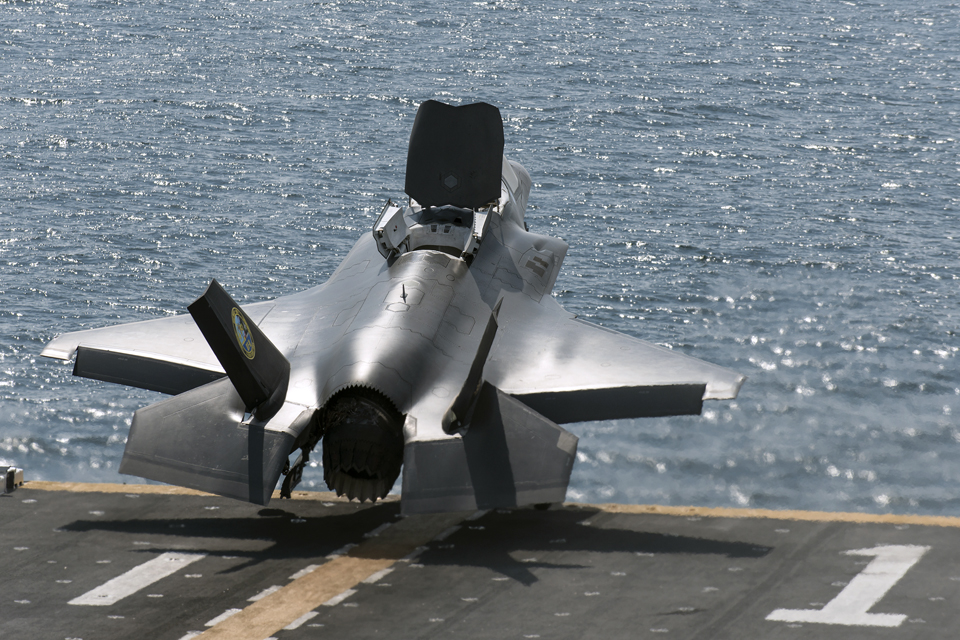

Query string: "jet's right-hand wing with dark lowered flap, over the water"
[483, 296, 746, 424]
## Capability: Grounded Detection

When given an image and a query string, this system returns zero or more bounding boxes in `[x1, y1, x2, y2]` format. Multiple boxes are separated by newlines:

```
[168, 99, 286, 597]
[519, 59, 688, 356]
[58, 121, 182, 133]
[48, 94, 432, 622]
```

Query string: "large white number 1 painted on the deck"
[767, 545, 930, 627]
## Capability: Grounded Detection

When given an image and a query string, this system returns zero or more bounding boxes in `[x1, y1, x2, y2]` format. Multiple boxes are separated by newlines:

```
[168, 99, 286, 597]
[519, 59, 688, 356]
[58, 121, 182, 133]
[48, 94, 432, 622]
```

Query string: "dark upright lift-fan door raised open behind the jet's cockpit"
[404, 100, 503, 209]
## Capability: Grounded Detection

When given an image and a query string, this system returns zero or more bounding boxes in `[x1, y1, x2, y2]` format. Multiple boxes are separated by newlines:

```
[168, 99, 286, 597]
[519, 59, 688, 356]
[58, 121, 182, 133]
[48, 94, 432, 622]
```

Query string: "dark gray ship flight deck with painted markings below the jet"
[0, 483, 960, 640]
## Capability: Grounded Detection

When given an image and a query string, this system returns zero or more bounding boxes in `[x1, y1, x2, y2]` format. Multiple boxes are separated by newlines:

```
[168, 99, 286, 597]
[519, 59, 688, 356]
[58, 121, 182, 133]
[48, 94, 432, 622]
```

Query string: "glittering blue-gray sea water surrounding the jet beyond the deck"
[0, 0, 960, 516]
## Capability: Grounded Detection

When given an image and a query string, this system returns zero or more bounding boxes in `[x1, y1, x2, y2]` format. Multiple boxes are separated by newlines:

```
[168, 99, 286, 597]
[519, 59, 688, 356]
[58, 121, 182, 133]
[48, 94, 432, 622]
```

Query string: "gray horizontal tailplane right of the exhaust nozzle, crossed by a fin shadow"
[402, 383, 577, 514]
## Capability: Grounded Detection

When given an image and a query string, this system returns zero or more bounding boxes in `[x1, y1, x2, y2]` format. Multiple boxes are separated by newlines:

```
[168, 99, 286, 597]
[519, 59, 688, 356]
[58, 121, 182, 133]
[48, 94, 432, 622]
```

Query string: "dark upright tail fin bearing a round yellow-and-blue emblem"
[187, 280, 290, 419]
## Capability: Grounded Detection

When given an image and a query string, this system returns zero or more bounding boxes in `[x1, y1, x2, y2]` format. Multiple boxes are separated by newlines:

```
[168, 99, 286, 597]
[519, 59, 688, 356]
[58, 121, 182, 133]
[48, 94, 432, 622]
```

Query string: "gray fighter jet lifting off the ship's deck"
[42, 100, 744, 514]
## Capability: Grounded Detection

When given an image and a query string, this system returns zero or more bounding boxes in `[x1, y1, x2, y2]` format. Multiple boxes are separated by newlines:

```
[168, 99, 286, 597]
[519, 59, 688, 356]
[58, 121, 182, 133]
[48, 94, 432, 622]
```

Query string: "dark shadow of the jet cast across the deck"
[62, 503, 773, 586]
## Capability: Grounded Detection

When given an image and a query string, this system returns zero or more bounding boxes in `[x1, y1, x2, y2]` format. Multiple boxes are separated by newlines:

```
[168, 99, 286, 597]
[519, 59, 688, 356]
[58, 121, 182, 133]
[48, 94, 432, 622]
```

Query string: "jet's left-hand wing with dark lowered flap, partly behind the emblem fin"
[40, 302, 273, 395]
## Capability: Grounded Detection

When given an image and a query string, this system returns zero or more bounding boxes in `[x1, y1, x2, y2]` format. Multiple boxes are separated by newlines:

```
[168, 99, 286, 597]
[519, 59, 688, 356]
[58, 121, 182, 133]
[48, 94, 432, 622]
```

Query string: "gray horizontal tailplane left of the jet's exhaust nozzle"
[120, 378, 312, 504]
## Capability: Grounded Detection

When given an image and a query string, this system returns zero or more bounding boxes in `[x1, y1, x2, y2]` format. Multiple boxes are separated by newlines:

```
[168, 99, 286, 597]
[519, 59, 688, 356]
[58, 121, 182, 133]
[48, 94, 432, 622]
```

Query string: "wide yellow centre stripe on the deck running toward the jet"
[197, 512, 469, 640]
